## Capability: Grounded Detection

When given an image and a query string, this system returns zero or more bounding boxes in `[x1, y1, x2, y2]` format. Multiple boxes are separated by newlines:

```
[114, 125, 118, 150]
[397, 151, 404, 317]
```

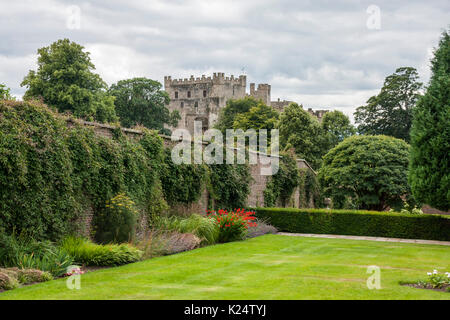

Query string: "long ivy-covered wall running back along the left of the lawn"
[0, 101, 318, 240]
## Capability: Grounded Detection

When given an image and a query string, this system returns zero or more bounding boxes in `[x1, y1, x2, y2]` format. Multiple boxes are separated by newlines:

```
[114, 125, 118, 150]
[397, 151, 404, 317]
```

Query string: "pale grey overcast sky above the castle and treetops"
[0, 0, 450, 120]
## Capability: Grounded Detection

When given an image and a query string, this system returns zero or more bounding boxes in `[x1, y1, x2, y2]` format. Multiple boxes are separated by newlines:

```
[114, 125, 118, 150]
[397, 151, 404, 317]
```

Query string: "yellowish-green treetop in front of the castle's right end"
[233, 102, 279, 131]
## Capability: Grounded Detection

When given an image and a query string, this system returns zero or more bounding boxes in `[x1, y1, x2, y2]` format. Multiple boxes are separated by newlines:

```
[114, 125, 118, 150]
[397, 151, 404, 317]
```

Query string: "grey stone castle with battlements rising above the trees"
[164, 72, 327, 134]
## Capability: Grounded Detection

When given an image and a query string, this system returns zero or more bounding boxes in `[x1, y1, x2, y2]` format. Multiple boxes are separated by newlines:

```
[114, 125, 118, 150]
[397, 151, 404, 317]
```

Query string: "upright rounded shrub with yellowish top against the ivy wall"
[94, 193, 138, 243]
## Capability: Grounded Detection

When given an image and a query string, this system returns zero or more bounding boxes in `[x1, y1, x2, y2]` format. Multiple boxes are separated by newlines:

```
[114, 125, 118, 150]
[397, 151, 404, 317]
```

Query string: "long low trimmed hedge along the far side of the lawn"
[252, 208, 450, 241]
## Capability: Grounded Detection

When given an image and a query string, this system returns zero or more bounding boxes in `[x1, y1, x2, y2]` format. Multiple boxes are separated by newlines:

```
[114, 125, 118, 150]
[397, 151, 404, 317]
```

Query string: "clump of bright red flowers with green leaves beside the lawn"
[206, 209, 257, 243]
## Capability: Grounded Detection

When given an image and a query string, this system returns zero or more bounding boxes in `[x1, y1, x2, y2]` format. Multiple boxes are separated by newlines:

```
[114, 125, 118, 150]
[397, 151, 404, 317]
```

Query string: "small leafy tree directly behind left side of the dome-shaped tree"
[320, 110, 356, 149]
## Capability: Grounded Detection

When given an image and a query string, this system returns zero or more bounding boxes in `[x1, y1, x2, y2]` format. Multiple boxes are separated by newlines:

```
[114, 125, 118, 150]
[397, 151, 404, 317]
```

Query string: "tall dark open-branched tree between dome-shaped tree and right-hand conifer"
[355, 67, 422, 142]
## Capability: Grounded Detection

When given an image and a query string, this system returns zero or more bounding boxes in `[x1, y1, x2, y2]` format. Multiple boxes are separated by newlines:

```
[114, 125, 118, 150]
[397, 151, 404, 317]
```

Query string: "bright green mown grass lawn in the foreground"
[0, 235, 450, 299]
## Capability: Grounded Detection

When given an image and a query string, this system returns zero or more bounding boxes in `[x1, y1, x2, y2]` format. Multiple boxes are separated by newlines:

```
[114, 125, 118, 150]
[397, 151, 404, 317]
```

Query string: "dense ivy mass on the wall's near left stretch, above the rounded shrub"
[0, 101, 164, 240]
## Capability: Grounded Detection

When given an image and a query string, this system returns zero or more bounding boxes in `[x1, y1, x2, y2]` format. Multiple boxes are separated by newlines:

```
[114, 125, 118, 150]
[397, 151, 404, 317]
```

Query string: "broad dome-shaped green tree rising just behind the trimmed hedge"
[319, 136, 409, 211]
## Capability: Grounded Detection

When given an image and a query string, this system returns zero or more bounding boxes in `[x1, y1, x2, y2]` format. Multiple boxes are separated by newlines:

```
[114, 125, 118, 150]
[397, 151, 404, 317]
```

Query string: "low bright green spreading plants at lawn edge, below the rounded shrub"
[61, 237, 142, 266]
